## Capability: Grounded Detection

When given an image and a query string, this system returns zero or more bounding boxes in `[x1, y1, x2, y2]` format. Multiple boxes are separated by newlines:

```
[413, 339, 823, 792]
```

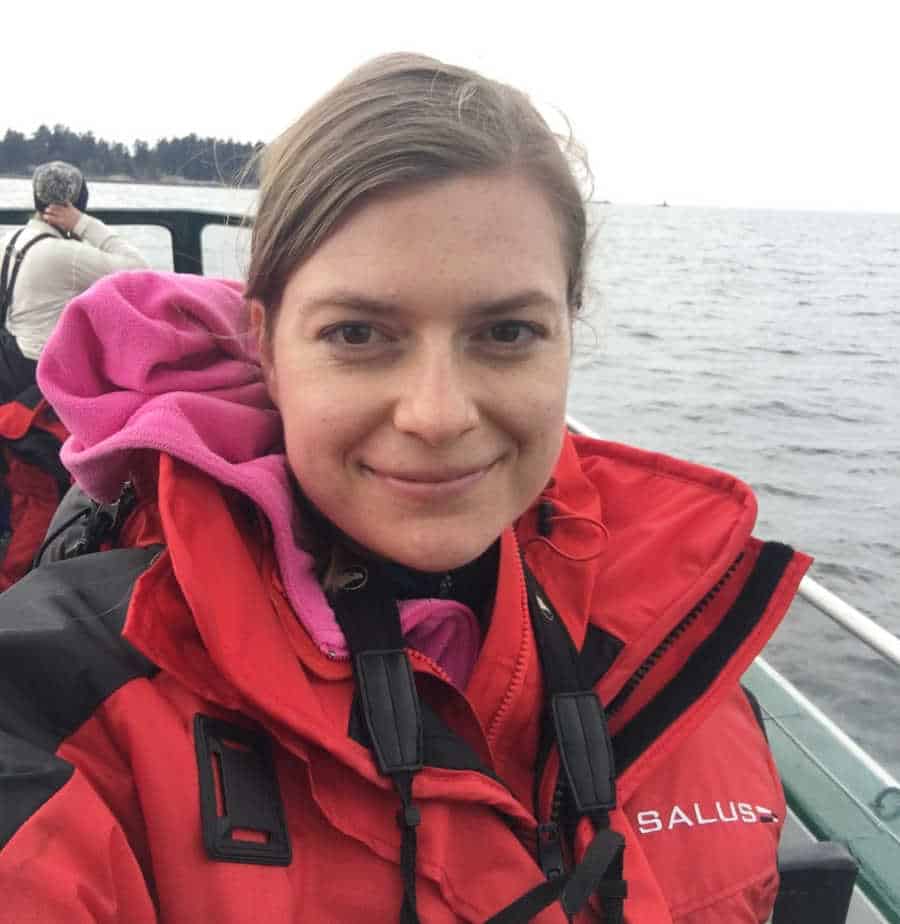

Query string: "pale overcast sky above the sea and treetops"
[0, 0, 900, 212]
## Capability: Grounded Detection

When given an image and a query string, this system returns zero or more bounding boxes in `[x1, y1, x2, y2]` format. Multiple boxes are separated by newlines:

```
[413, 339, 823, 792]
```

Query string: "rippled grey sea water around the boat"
[0, 180, 900, 775]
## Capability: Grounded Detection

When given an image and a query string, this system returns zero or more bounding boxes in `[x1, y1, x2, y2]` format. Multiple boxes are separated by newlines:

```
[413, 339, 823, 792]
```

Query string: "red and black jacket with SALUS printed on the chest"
[0, 438, 809, 924]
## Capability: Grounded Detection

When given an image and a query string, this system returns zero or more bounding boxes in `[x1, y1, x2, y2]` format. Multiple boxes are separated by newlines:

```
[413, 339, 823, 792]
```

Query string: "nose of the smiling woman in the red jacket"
[394, 345, 479, 446]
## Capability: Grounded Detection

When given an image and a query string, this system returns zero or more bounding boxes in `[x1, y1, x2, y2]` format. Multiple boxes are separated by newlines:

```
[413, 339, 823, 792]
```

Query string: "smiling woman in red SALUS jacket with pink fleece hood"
[0, 55, 808, 924]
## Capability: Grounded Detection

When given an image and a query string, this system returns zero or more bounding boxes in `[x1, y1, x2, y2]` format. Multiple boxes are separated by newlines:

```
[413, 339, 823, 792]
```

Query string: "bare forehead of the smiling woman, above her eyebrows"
[285, 174, 567, 312]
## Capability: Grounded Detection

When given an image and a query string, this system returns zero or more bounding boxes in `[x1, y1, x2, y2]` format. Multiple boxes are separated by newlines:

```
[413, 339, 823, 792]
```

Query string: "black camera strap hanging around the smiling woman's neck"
[330, 566, 625, 924]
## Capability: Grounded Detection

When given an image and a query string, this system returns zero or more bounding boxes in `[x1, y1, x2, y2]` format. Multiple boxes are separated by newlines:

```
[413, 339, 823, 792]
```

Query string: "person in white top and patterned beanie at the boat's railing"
[0, 160, 148, 402]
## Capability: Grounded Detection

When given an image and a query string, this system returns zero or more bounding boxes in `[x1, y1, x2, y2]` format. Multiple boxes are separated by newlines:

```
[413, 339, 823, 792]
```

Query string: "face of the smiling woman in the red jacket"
[253, 175, 571, 571]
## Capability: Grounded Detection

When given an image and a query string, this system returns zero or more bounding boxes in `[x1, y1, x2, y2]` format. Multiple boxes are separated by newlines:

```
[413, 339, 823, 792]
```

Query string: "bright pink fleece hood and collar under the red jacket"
[38, 271, 480, 687]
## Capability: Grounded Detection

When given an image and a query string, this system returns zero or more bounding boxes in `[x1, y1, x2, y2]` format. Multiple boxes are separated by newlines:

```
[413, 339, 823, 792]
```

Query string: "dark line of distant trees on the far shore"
[0, 125, 261, 183]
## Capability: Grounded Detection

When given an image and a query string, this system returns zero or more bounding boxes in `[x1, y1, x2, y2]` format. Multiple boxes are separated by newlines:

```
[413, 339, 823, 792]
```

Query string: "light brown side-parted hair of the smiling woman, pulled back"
[246, 54, 587, 322]
